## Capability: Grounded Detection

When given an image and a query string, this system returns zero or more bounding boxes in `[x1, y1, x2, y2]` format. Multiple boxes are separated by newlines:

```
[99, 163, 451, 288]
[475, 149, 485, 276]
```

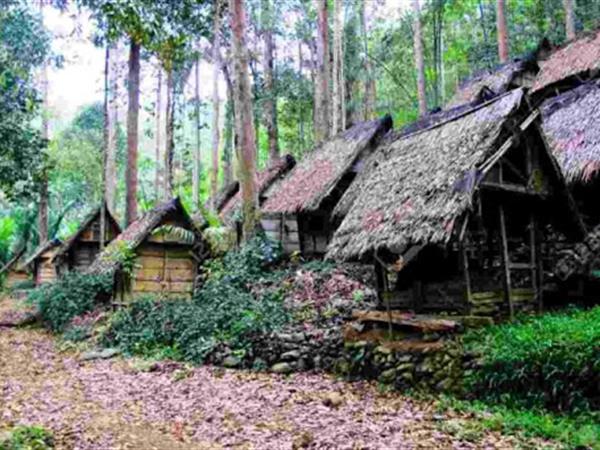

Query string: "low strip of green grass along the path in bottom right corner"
[438, 396, 600, 449]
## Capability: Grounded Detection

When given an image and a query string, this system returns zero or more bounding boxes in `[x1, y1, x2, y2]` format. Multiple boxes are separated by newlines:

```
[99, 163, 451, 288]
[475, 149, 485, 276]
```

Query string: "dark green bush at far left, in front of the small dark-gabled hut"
[28, 272, 113, 331]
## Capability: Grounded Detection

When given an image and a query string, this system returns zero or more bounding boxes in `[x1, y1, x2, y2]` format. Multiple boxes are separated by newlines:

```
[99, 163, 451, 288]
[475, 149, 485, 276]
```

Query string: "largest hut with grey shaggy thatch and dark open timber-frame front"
[328, 89, 583, 316]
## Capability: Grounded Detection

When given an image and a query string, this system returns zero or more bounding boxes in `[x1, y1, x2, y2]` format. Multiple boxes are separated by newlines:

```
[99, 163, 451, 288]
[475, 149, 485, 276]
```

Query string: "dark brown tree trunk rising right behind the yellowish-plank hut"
[125, 39, 140, 225]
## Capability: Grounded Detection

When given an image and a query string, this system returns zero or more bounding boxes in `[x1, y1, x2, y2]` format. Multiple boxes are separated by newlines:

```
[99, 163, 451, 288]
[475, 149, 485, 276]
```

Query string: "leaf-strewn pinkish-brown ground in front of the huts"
[0, 300, 554, 450]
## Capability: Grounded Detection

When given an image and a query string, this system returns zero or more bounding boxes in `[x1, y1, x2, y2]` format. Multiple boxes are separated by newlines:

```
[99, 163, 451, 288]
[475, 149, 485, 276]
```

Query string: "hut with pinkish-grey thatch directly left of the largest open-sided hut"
[261, 116, 392, 256]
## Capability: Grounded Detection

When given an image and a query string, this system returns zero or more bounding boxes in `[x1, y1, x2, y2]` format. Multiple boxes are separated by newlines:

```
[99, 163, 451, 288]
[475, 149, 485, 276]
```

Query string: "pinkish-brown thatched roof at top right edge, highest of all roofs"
[531, 30, 600, 93]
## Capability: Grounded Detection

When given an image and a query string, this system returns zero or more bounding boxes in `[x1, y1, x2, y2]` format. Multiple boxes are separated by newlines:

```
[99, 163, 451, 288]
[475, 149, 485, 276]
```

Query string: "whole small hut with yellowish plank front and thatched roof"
[89, 198, 206, 303]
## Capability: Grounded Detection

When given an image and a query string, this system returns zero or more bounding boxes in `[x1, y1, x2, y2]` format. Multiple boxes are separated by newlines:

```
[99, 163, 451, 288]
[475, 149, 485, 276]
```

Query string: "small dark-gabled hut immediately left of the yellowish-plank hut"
[52, 206, 121, 273]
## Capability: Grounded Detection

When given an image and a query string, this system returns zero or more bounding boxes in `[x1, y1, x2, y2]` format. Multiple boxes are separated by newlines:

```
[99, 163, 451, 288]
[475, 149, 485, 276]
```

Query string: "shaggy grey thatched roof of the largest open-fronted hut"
[328, 89, 524, 259]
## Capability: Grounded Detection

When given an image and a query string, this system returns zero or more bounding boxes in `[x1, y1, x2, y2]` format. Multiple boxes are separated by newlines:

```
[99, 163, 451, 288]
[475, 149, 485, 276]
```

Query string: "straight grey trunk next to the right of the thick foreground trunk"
[261, 0, 279, 162]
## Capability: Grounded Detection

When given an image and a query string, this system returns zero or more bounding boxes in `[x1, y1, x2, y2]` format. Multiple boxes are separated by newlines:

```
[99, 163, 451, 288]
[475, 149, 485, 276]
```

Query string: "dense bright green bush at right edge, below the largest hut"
[465, 307, 600, 411]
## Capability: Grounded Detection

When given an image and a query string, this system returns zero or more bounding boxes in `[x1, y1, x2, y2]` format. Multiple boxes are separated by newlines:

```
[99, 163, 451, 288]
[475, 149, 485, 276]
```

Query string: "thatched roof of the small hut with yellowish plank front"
[88, 197, 202, 273]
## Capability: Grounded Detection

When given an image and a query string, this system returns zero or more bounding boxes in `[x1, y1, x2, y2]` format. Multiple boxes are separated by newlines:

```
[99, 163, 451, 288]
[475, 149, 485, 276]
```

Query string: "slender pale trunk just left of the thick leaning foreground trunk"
[210, 0, 221, 212]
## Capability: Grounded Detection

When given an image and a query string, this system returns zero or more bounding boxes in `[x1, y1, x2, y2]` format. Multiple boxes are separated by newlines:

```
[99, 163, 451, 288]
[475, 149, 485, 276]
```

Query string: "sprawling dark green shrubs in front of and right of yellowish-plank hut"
[103, 238, 288, 363]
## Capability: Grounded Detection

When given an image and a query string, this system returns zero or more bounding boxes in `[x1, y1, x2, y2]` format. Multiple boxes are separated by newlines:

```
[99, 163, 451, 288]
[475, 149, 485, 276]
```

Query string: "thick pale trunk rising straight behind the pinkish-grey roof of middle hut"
[314, 0, 330, 144]
